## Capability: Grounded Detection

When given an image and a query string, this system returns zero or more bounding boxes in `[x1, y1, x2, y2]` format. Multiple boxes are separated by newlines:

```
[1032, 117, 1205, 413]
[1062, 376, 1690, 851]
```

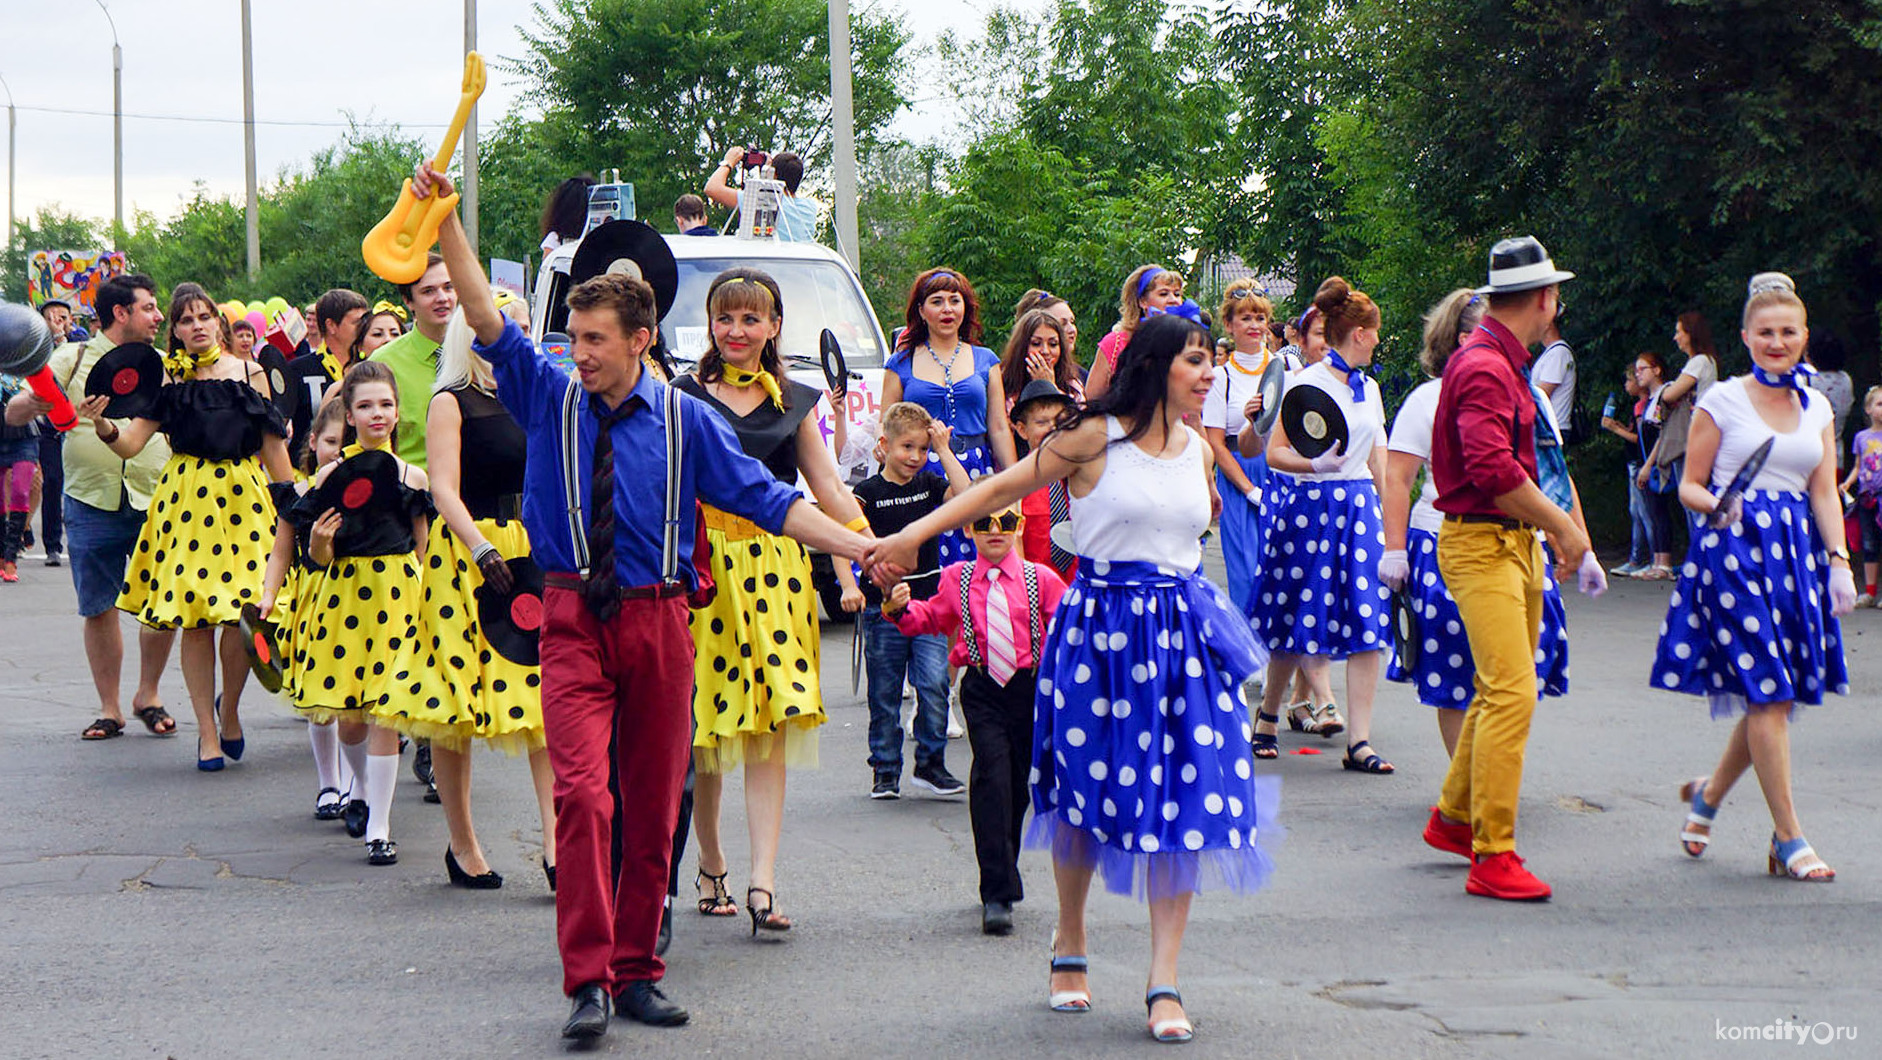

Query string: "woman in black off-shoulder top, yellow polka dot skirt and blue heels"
[79, 284, 290, 772]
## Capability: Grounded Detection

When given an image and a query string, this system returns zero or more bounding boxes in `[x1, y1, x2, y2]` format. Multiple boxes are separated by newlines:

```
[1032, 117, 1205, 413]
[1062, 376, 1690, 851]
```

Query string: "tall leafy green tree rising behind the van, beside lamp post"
[508, 0, 909, 230]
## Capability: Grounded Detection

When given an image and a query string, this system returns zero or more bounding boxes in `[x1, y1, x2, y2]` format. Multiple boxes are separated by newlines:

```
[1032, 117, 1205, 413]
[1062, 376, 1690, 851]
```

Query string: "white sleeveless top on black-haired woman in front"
[1071, 416, 1208, 574]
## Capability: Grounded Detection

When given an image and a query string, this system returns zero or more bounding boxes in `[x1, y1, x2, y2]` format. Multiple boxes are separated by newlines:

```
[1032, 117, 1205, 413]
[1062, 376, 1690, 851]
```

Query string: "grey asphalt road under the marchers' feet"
[0, 542, 1882, 1060]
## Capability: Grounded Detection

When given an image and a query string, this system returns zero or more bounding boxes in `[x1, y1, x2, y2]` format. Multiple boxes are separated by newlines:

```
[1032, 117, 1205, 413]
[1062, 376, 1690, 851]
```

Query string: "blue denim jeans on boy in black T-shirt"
[856, 608, 947, 778]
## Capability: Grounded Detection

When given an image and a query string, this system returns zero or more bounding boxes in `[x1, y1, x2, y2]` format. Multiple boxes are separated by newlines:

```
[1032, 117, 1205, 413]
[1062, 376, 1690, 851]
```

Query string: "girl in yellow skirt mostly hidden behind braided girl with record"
[260, 397, 353, 821]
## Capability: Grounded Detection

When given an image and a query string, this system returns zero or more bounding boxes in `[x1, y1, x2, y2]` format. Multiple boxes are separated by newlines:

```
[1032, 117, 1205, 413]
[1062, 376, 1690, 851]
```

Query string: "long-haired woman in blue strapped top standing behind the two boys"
[883, 269, 1014, 567]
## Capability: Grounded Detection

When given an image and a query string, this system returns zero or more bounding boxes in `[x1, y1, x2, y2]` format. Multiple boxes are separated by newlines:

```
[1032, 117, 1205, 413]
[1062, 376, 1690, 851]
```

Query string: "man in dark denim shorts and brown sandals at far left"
[6, 273, 177, 740]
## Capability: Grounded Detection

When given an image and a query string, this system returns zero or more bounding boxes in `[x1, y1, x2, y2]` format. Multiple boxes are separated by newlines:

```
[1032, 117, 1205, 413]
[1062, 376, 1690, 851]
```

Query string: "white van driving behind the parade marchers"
[531, 235, 888, 621]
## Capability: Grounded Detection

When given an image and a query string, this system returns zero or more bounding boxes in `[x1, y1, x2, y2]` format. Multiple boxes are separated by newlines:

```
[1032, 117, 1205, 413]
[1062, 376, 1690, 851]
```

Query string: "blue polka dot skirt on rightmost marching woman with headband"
[1652, 490, 1850, 717]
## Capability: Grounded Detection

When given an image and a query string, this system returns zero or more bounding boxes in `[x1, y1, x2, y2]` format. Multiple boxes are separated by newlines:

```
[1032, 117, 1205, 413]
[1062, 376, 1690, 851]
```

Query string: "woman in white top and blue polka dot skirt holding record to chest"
[1253, 277, 1393, 774]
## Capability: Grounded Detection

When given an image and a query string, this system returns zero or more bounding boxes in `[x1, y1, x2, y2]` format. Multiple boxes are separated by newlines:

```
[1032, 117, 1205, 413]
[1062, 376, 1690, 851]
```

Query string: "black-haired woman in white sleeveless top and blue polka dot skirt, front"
[869, 316, 1280, 1041]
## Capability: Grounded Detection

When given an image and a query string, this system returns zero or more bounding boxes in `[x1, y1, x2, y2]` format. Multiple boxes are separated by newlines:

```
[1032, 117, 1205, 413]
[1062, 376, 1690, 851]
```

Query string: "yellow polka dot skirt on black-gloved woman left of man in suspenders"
[376, 520, 542, 755]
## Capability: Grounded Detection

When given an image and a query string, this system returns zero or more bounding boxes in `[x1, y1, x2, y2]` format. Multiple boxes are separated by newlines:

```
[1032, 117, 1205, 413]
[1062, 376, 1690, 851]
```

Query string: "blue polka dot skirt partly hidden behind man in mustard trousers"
[1385, 529, 1568, 710]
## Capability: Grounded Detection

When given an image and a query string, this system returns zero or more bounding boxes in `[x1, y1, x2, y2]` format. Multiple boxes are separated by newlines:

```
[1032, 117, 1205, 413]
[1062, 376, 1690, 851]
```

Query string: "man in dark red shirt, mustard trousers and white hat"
[1425, 235, 1588, 902]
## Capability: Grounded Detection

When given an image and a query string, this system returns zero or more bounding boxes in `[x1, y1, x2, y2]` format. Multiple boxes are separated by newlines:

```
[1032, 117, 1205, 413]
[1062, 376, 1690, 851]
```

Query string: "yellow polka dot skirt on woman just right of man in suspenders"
[689, 527, 824, 774]
